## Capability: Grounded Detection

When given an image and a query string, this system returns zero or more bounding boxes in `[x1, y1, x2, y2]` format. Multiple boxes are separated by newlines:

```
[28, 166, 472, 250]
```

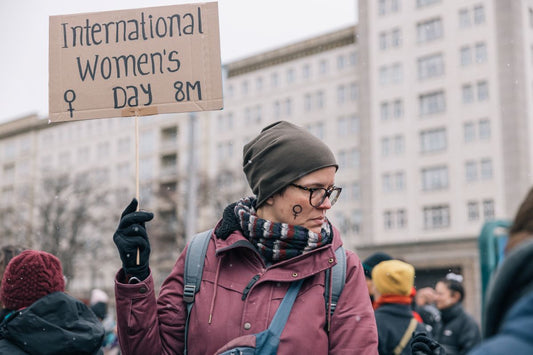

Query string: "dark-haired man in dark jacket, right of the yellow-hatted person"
[435, 273, 481, 355]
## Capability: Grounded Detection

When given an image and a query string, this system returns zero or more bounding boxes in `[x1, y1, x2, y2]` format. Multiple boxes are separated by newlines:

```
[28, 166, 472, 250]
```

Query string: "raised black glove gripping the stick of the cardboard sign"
[113, 198, 154, 280]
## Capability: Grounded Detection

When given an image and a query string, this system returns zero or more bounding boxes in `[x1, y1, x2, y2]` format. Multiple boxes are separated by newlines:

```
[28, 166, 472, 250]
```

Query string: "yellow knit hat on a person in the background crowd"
[372, 260, 415, 296]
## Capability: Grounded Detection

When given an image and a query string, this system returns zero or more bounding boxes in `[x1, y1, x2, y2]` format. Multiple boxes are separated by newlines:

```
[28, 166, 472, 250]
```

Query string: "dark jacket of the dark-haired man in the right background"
[435, 303, 481, 355]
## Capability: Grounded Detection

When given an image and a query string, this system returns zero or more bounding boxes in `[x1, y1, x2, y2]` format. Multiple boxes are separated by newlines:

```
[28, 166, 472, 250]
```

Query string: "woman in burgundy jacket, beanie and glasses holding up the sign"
[114, 121, 377, 355]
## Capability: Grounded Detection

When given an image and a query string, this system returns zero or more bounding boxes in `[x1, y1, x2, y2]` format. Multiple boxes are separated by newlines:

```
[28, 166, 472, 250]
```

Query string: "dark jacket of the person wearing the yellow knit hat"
[375, 303, 425, 355]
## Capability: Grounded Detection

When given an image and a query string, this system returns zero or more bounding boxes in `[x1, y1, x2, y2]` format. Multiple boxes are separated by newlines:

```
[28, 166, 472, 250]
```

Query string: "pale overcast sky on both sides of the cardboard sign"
[0, 0, 357, 122]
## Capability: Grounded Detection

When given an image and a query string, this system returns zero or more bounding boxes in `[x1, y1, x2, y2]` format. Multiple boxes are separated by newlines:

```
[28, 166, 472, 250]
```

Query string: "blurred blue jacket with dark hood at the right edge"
[469, 242, 533, 355]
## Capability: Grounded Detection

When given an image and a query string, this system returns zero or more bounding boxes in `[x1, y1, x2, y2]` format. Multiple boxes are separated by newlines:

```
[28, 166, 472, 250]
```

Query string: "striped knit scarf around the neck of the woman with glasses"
[234, 197, 333, 262]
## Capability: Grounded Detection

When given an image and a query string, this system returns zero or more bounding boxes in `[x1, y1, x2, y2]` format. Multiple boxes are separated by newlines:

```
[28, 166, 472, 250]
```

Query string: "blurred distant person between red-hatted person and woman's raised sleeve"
[89, 288, 120, 355]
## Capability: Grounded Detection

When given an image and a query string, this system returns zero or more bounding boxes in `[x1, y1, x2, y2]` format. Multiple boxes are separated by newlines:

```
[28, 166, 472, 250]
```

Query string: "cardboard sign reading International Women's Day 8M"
[49, 2, 223, 122]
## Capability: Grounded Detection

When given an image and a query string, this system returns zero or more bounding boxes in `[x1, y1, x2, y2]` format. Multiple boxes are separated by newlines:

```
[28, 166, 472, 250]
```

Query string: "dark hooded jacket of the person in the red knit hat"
[0, 292, 104, 355]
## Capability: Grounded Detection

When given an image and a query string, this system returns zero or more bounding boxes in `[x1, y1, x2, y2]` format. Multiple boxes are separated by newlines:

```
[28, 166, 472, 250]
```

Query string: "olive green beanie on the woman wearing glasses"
[243, 121, 338, 208]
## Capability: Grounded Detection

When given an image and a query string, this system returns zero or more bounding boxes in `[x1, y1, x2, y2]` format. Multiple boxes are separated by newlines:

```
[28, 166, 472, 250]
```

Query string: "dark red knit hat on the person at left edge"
[0, 250, 65, 310]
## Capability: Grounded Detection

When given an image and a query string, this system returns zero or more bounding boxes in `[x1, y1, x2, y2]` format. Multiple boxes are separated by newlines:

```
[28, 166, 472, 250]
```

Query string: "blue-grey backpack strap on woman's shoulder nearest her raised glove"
[183, 229, 213, 354]
